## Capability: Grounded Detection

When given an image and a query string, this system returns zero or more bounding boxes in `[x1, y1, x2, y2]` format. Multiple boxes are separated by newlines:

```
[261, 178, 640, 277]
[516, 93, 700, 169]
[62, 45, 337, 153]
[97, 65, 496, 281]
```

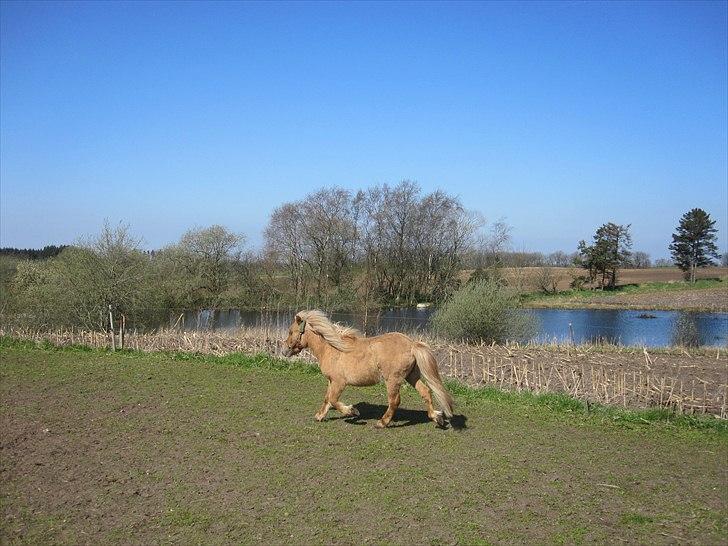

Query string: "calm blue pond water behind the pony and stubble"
[178, 309, 728, 347]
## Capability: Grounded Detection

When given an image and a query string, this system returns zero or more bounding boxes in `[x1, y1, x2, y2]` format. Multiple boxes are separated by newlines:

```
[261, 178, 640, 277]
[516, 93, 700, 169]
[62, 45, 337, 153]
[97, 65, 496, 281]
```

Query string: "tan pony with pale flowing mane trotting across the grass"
[285, 311, 453, 428]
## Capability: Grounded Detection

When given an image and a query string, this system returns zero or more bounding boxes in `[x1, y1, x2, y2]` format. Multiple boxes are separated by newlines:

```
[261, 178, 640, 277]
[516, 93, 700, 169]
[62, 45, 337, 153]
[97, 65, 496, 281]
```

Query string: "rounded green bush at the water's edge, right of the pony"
[432, 280, 536, 343]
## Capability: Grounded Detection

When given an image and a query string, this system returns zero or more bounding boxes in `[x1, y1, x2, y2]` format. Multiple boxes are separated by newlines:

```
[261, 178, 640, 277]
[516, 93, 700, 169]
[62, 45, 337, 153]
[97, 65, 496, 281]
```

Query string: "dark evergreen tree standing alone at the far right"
[668, 209, 718, 282]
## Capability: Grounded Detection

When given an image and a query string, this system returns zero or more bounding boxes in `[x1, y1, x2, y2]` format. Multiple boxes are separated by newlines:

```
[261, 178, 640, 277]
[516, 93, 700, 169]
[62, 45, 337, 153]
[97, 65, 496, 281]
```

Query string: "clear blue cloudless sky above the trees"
[0, 1, 728, 258]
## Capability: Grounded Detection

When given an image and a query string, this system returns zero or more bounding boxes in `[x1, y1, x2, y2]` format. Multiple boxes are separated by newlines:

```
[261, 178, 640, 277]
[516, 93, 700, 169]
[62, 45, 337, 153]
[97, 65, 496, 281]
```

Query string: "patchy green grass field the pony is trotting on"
[0, 340, 728, 544]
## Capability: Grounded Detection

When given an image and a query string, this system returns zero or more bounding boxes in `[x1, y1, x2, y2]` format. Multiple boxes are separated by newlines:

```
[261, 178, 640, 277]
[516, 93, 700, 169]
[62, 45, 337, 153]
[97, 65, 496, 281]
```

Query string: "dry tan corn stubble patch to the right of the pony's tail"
[435, 345, 728, 418]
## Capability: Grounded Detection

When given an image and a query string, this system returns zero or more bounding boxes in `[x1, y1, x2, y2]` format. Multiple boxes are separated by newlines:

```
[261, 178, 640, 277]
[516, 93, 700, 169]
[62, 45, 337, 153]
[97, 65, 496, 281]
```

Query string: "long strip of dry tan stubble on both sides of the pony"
[0, 328, 728, 419]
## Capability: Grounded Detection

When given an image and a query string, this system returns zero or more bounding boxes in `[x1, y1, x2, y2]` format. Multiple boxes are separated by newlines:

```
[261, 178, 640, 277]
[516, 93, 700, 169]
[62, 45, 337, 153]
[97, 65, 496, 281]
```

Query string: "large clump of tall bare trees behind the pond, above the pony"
[266, 180, 482, 305]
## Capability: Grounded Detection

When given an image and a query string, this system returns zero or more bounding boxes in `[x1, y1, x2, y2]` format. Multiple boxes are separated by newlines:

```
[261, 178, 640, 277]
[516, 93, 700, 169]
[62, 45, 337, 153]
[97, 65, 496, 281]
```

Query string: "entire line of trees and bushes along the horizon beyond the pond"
[0, 181, 717, 328]
